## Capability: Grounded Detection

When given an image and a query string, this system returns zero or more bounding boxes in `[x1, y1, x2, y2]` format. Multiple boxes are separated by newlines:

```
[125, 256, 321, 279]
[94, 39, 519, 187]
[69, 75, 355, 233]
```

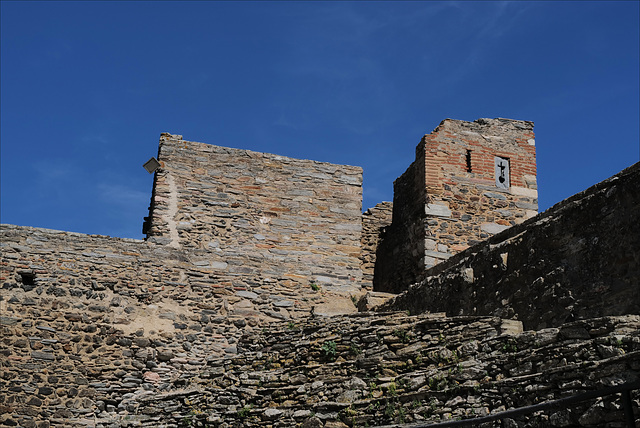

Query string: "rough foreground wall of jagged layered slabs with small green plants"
[127, 313, 640, 428]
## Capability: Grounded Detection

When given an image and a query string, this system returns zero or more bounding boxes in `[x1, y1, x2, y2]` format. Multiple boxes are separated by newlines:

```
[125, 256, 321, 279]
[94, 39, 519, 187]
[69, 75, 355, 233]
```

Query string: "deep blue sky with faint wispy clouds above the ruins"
[0, 1, 640, 238]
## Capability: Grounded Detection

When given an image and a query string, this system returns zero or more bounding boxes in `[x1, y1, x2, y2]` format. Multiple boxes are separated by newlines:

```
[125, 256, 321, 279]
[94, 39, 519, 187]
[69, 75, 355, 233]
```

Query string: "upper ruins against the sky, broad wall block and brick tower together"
[144, 119, 537, 293]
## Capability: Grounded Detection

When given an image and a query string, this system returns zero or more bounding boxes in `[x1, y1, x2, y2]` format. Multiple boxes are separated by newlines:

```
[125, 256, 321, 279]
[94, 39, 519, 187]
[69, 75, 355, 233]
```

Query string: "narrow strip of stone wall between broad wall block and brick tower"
[361, 202, 393, 289]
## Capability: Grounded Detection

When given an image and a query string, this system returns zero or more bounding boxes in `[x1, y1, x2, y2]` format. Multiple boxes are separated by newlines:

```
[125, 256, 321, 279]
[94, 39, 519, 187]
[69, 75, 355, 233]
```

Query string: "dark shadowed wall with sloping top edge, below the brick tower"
[380, 164, 640, 329]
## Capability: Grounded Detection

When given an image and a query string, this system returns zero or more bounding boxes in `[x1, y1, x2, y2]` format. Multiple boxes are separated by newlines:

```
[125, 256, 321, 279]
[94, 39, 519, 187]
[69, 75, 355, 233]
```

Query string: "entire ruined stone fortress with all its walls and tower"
[0, 119, 640, 428]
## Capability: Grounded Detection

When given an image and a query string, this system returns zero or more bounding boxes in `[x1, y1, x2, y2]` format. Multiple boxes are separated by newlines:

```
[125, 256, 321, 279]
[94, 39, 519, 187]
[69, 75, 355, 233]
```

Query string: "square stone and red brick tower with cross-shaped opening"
[374, 119, 538, 292]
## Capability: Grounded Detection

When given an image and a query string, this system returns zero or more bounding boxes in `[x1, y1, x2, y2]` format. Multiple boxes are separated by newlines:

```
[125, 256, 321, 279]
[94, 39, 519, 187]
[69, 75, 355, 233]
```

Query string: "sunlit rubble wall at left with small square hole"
[0, 225, 348, 427]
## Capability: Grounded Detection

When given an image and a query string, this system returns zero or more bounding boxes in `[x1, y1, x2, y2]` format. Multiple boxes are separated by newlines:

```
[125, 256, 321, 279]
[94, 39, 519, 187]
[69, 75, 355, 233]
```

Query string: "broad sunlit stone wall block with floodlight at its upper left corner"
[145, 134, 362, 290]
